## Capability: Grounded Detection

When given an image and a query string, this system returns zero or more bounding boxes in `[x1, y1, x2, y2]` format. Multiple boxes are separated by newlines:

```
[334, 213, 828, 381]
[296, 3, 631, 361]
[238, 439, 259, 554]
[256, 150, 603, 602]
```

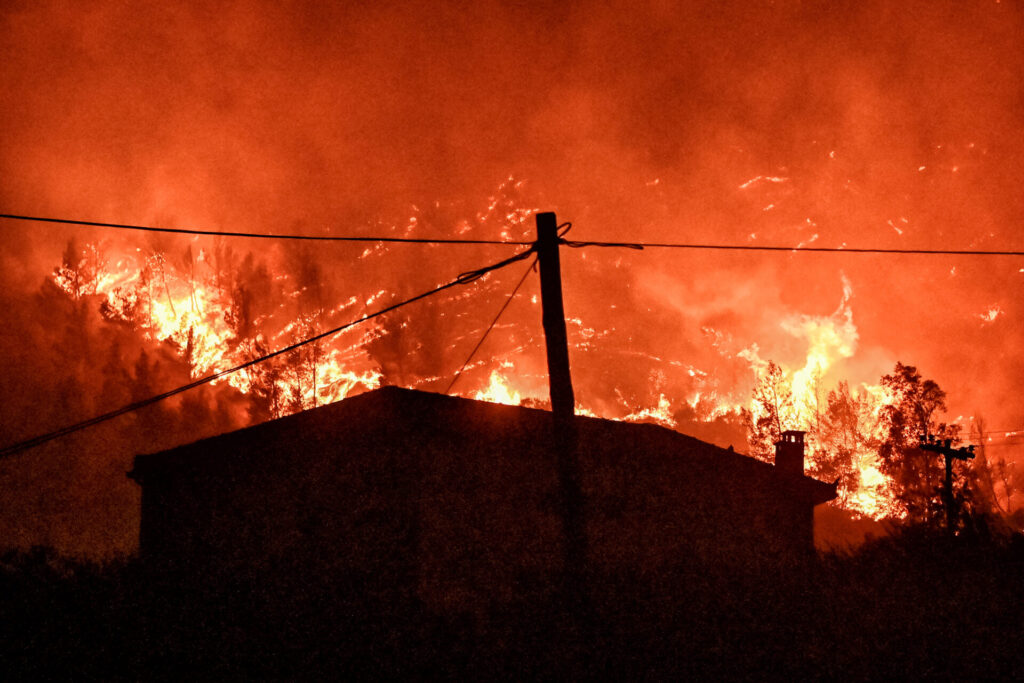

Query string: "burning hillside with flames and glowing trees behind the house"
[37, 179, 1013, 519]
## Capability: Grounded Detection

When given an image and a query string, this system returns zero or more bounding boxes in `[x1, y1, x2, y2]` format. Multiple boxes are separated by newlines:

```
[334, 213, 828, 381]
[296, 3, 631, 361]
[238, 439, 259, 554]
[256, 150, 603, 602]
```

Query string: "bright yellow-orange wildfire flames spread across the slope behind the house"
[53, 227, 921, 518]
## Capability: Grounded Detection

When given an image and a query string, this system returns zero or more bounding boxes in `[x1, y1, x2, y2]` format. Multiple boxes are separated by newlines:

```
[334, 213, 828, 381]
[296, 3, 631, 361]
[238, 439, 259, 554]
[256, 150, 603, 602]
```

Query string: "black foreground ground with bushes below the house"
[0, 532, 1024, 681]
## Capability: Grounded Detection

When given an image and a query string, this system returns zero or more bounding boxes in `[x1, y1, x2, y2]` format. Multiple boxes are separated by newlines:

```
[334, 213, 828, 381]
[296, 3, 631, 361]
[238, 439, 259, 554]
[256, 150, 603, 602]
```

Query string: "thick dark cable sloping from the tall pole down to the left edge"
[0, 248, 534, 458]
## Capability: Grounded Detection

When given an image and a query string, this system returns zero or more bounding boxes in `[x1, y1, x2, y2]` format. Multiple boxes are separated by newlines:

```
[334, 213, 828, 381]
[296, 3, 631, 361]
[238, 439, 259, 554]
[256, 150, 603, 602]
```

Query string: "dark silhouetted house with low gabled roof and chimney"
[129, 387, 836, 607]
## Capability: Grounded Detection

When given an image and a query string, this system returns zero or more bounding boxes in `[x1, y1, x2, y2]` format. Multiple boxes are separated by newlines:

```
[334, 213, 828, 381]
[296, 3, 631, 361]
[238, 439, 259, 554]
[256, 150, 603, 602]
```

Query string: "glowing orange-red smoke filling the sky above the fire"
[0, 0, 1024, 550]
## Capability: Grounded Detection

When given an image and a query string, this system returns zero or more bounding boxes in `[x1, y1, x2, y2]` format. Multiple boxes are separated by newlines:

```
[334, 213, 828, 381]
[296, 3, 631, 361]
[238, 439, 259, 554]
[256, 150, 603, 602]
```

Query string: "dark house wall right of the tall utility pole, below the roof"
[583, 436, 813, 569]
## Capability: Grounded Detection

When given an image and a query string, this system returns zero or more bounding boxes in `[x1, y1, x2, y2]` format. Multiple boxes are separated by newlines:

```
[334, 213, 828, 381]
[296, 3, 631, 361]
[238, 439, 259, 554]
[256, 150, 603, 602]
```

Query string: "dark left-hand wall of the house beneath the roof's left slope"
[140, 421, 414, 593]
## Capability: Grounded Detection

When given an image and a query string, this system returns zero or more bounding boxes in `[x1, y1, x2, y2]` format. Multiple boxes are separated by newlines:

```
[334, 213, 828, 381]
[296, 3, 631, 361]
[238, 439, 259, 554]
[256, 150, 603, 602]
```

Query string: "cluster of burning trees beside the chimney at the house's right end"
[743, 361, 1016, 524]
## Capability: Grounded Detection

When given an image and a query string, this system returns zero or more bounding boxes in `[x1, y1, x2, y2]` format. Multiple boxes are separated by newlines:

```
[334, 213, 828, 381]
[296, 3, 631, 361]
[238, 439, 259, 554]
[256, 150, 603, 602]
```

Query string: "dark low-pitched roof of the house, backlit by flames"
[129, 386, 837, 505]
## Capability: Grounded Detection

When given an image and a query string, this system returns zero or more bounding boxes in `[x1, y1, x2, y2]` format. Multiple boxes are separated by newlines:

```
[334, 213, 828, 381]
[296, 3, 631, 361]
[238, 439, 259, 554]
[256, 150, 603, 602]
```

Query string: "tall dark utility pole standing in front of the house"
[537, 213, 589, 618]
